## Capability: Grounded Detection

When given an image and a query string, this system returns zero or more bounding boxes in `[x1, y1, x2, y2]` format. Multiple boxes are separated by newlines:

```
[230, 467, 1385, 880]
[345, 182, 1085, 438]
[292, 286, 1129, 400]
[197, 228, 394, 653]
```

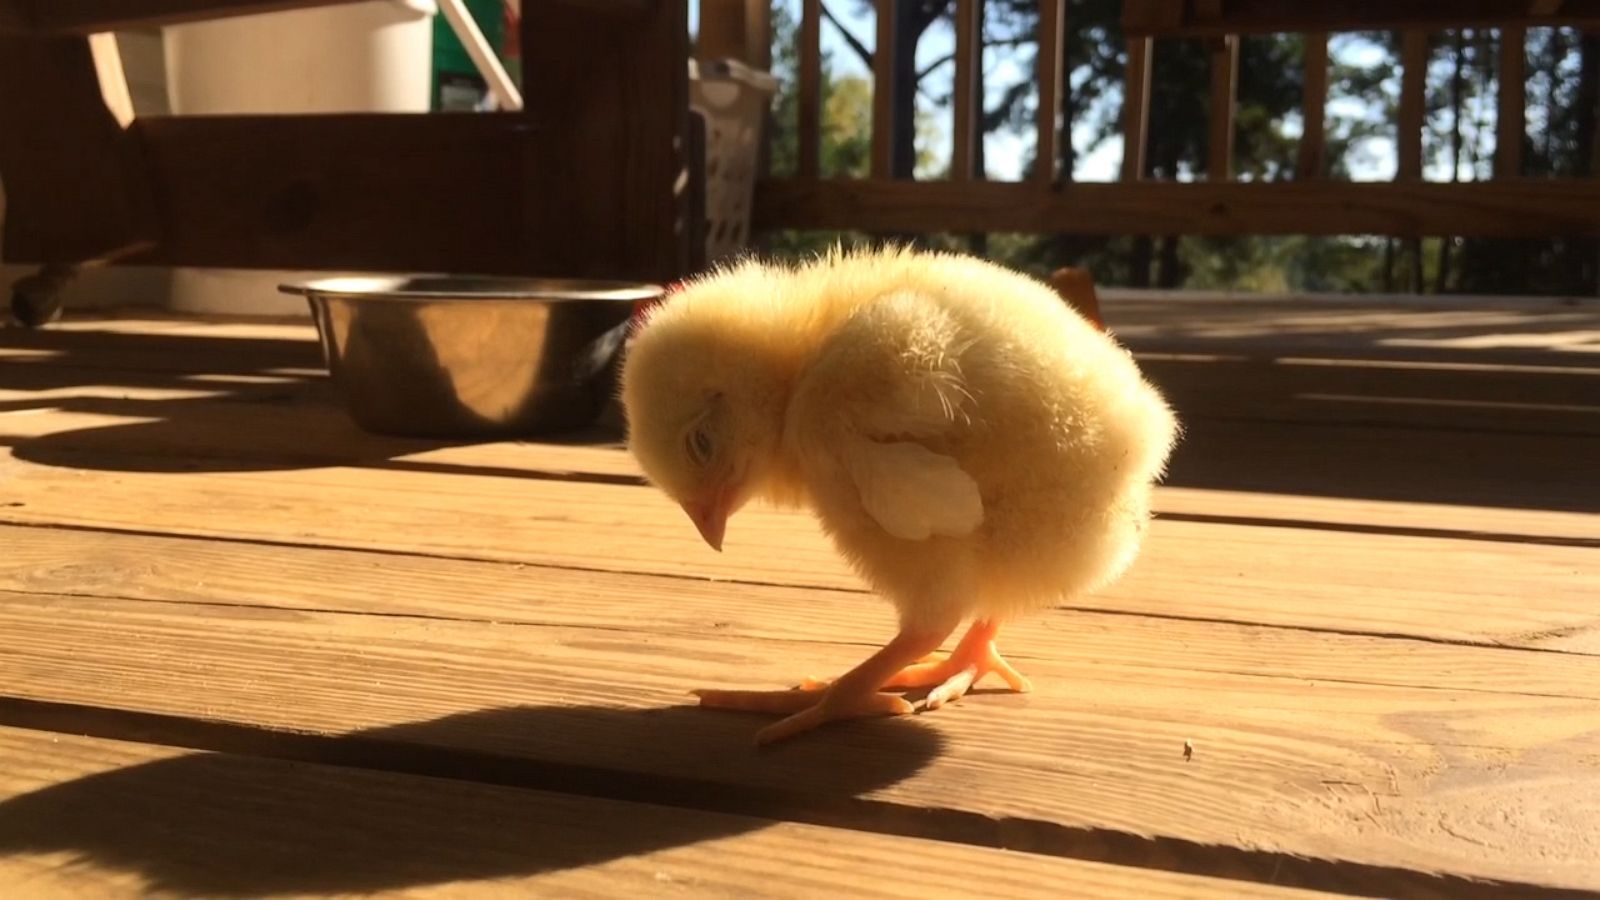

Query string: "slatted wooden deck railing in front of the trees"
[748, 0, 1600, 237]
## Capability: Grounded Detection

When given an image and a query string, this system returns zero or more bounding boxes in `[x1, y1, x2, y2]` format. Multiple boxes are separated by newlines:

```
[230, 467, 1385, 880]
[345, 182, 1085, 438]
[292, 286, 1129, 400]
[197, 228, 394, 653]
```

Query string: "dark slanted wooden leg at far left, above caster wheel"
[0, 37, 160, 263]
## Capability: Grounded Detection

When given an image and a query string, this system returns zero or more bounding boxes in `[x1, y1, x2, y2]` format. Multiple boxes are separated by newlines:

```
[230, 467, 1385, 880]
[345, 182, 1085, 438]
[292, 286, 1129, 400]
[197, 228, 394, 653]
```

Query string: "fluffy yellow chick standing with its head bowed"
[621, 248, 1179, 743]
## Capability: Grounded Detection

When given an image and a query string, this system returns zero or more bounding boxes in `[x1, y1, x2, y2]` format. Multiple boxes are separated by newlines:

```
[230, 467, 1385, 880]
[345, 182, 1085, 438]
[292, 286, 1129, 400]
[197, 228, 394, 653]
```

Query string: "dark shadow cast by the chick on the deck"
[0, 706, 941, 897]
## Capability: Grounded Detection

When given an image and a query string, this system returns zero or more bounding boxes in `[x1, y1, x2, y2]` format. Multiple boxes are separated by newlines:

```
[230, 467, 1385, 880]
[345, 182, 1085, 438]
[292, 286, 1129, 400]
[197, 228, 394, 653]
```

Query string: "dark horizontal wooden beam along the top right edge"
[1122, 0, 1600, 37]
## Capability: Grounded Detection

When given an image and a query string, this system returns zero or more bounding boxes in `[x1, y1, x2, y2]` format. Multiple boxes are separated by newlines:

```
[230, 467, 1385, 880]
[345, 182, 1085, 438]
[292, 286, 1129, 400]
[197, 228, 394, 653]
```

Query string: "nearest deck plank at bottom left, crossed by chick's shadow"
[0, 725, 1286, 900]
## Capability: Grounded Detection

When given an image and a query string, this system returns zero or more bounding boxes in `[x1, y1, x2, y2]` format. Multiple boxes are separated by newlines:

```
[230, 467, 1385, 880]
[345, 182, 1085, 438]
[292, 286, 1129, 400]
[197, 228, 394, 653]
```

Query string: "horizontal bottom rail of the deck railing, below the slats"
[755, 179, 1600, 237]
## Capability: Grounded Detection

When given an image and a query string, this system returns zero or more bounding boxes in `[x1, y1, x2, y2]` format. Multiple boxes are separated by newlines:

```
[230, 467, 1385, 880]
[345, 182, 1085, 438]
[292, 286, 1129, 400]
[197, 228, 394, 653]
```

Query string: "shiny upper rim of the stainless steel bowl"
[278, 274, 666, 303]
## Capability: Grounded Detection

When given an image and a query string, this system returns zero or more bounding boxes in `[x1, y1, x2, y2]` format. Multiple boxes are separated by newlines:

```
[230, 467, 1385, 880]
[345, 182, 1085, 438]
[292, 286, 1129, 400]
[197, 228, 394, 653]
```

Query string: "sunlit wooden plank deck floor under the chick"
[0, 293, 1600, 898]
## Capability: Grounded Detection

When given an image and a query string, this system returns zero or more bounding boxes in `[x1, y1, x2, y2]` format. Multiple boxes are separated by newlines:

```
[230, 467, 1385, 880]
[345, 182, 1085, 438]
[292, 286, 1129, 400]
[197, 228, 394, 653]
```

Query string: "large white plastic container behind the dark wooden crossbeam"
[163, 0, 437, 315]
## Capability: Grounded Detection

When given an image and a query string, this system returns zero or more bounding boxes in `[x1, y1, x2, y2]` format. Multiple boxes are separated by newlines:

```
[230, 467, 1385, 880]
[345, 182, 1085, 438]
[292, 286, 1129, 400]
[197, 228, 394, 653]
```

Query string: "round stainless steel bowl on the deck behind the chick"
[278, 275, 662, 437]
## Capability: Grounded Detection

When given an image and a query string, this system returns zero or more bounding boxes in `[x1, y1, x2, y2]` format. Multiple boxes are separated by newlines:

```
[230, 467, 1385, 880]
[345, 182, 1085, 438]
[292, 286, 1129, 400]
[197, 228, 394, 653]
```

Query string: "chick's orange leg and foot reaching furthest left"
[694, 626, 954, 743]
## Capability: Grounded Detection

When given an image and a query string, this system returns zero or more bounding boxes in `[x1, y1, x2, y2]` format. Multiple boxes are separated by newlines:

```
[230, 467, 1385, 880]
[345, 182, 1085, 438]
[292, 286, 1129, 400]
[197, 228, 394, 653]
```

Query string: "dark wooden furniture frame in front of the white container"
[0, 0, 691, 282]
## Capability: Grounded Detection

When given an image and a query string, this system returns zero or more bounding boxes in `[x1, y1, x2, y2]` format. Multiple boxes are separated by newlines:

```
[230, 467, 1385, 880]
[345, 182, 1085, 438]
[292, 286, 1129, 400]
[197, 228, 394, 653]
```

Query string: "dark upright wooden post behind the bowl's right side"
[524, 2, 690, 283]
